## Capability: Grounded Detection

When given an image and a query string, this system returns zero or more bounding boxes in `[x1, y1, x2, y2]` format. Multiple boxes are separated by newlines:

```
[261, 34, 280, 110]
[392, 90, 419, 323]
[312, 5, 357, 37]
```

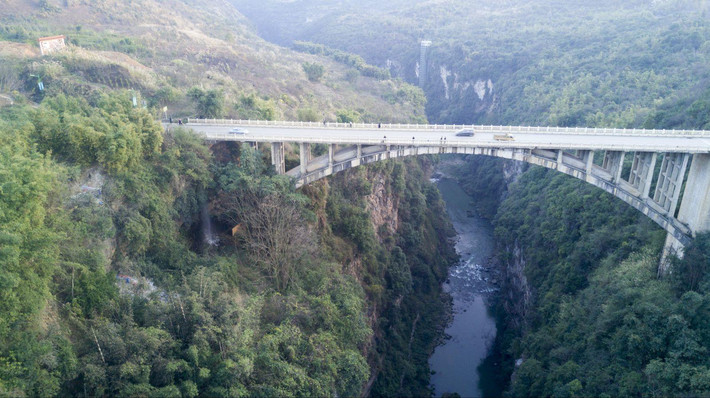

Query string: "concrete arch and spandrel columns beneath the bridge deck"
[262, 143, 710, 251]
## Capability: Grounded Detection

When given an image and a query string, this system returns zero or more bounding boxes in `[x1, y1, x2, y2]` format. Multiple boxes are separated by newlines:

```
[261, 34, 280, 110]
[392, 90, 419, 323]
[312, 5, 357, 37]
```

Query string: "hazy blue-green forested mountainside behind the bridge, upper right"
[231, 0, 710, 127]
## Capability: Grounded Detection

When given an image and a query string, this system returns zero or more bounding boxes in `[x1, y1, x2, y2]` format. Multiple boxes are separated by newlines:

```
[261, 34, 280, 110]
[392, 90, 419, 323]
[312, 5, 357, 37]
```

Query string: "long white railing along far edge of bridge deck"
[188, 118, 710, 137]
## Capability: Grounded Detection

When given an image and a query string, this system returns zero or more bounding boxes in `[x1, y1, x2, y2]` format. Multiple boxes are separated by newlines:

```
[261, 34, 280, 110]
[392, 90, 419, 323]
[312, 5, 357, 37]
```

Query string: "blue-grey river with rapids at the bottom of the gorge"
[429, 178, 500, 397]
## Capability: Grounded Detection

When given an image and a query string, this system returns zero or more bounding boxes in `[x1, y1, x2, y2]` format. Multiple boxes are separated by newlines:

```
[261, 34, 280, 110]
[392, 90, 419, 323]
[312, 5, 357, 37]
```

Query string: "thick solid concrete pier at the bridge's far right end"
[659, 154, 710, 273]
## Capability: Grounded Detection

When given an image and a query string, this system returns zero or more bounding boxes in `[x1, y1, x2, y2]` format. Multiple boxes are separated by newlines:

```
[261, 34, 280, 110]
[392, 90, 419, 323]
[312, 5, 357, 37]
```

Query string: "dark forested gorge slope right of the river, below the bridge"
[482, 164, 710, 397]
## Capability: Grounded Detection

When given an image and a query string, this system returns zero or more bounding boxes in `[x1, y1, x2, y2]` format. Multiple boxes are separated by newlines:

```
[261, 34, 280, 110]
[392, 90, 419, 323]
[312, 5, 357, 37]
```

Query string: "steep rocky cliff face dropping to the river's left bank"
[304, 159, 455, 396]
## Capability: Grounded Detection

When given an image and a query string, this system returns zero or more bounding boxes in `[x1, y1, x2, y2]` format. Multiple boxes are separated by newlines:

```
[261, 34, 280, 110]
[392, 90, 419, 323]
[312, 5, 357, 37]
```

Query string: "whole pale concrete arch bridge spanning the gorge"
[188, 119, 710, 258]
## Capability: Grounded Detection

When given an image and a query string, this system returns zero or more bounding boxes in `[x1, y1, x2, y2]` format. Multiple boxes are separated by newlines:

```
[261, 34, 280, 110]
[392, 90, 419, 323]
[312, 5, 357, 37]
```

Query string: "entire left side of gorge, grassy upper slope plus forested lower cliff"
[0, 0, 455, 397]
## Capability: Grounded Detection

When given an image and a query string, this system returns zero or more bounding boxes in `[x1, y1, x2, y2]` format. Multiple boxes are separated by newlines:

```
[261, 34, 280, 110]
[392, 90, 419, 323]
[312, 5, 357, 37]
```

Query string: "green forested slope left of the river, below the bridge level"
[0, 92, 453, 396]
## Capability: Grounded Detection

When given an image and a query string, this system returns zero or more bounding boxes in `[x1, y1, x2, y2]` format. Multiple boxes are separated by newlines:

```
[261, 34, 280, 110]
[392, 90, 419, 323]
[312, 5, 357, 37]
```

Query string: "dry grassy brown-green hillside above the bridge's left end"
[0, 0, 424, 121]
